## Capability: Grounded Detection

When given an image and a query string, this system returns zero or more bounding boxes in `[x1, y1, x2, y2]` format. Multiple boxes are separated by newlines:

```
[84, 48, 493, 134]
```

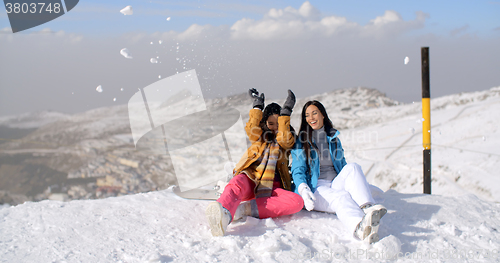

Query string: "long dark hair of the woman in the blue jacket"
[299, 100, 333, 169]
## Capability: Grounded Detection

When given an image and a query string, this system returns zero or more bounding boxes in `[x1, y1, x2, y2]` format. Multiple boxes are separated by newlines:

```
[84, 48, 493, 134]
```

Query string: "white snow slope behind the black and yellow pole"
[340, 88, 500, 202]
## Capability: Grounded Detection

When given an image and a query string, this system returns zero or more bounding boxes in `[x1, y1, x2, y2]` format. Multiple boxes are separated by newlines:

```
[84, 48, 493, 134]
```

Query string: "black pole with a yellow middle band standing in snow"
[421, 47, 431, 194]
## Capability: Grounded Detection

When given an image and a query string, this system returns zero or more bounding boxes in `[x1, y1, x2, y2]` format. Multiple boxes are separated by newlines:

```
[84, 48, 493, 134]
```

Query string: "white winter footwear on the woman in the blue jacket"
[354, 204, 387, 244]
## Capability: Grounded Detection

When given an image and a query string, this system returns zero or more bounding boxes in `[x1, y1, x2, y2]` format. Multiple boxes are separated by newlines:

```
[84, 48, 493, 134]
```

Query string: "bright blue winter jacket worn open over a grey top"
[291, 128, 347, 193]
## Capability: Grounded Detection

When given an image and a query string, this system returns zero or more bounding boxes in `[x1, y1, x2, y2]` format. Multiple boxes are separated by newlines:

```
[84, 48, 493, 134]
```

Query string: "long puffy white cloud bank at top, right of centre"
[227, 1, 427, 40]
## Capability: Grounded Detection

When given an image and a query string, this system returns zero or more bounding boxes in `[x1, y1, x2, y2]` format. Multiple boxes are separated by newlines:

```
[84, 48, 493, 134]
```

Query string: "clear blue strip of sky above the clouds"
[0, 0, 500, 37]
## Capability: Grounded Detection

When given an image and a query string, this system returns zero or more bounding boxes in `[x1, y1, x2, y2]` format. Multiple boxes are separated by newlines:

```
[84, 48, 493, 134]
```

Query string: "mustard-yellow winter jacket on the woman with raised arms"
[234, 109, 295, 191]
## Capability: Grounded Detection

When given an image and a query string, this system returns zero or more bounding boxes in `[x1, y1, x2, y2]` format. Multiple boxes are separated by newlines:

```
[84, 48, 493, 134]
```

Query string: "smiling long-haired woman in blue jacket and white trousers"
[291, 100, 387, 243]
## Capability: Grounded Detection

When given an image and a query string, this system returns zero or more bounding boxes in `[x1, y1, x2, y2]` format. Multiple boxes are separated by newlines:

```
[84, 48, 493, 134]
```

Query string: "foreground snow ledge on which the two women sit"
[0, 189, 500, 262]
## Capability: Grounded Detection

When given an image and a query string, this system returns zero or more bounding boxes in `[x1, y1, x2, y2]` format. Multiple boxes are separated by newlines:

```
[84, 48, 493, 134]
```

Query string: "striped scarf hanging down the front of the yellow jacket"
[254, 141, 280, 198]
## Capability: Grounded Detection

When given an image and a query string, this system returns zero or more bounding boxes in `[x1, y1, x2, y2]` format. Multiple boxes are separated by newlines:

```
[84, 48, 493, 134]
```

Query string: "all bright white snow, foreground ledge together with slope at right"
[0, 88, 500, 262]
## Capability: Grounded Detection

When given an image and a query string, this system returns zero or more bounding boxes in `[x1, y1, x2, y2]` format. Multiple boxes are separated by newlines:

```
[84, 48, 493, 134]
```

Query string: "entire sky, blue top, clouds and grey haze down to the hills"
[0, 0, 500, 116]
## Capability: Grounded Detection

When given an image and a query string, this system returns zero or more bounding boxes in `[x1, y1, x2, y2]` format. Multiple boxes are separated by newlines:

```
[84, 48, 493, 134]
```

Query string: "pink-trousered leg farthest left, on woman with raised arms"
[217, 173, 255, 220]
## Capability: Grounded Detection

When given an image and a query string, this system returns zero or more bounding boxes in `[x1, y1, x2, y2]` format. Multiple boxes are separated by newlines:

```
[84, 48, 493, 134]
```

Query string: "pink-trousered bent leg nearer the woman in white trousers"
[256, 182, 304, 218]
